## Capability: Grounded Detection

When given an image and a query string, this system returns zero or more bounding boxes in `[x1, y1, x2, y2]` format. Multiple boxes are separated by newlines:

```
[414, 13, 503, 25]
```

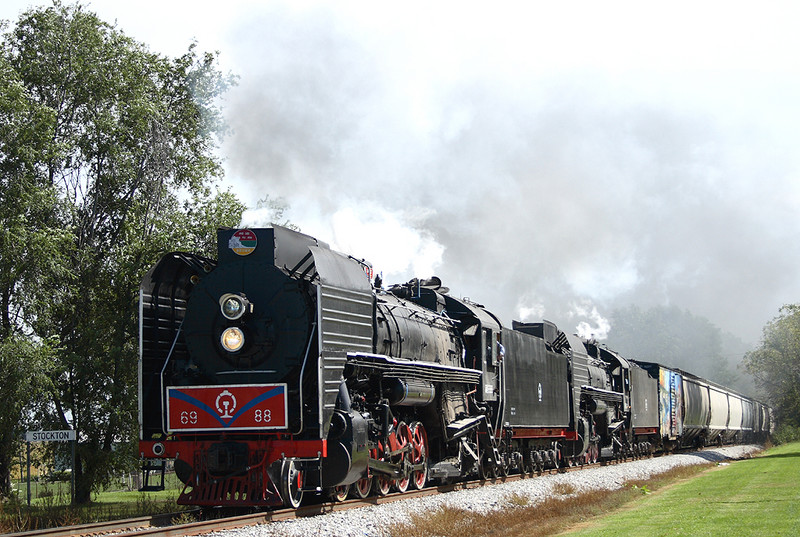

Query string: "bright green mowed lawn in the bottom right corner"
[562, 443, 800, 537]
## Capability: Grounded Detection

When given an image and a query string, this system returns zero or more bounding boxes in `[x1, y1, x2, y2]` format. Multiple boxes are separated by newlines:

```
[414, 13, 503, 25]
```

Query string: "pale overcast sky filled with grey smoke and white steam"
[0, 0, 800, 342]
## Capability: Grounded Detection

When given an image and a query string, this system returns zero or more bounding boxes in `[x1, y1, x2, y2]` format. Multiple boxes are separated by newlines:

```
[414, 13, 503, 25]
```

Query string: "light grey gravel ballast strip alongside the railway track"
[210, 445, 762, 537]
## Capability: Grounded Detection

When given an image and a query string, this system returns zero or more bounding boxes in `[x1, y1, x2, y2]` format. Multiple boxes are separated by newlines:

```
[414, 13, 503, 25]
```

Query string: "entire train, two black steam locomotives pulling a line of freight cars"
[139, 226, 770, 507]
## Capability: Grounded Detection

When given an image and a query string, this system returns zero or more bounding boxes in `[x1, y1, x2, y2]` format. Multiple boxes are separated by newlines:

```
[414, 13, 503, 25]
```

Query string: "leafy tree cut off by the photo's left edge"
[0, 28, 71, 497]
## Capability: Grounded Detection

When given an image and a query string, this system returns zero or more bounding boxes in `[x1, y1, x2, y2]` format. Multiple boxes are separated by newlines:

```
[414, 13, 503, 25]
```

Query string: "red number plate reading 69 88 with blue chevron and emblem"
[167, 384, 287, 432]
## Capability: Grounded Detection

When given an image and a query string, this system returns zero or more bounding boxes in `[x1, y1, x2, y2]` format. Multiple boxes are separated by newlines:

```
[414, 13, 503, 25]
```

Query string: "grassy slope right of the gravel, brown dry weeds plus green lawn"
[391, 443, 800, 537]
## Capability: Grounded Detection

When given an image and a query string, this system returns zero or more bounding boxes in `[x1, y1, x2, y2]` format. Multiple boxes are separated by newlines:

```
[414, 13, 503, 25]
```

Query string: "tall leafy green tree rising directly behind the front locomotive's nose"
[0, 2, 242, 502]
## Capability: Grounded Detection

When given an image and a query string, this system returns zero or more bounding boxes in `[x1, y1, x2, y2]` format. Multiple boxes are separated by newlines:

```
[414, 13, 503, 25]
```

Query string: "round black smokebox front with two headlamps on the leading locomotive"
[184, 259, 313, 384]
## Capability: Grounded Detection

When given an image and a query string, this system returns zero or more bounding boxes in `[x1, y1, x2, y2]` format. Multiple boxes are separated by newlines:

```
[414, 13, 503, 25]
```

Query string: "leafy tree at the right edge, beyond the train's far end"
[744, 304, 800, 430]
